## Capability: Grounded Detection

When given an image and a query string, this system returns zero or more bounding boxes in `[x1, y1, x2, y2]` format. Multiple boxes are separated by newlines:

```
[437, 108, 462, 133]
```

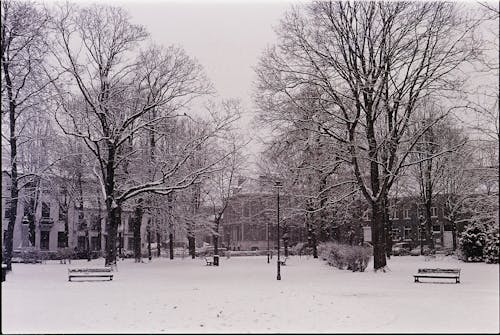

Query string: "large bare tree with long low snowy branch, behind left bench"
[51, 1, 239, 265]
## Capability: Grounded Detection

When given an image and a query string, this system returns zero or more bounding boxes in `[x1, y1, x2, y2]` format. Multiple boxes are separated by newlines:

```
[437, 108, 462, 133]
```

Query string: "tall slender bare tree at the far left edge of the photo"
[0, 0, 55, 270]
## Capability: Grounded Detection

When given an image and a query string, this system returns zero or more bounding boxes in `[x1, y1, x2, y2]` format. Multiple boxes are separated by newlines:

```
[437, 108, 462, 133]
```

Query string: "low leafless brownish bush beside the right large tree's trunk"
[318, 243, 371, 272]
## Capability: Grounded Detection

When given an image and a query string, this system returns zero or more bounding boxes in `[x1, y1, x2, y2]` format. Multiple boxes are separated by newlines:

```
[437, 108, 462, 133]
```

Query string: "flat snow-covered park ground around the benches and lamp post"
[2, 256, 499, 334]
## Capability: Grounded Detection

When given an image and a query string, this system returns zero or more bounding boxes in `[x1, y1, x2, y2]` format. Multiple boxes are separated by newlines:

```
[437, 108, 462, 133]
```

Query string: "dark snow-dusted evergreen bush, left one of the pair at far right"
[459, 223, 487, 262]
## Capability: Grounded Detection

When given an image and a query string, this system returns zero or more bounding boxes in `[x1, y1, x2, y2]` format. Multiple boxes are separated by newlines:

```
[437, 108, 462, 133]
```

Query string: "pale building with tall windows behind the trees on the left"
[1, 171, 208, 257]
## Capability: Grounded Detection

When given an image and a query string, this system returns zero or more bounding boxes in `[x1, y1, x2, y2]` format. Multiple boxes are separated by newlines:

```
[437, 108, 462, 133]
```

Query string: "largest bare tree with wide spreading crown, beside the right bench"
[257, 1, 477, 270]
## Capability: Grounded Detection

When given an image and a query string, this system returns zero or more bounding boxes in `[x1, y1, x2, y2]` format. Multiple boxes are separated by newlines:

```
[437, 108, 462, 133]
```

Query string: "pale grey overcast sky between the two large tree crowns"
[107, 0, 297, 167]
